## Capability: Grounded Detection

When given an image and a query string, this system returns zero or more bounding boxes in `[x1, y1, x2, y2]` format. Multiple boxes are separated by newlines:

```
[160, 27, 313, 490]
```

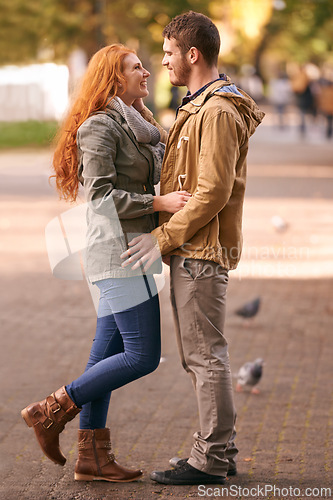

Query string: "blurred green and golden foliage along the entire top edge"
[0, 0, 333, 68]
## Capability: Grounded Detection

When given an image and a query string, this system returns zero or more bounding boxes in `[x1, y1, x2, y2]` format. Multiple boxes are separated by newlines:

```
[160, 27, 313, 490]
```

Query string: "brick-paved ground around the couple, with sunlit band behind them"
[0, 110, 333, 500]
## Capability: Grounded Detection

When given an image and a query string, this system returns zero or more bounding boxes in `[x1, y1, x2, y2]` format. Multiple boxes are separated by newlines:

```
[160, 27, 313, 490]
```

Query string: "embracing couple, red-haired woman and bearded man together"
[21, 11, 263, 485]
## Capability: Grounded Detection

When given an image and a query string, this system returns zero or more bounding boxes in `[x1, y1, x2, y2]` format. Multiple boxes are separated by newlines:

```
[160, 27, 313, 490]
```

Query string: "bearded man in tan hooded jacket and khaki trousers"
[123, 12, 264, 484]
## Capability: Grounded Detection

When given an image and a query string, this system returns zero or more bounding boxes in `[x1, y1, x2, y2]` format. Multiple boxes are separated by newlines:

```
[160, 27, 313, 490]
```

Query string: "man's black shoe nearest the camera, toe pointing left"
[150, 462, 225, 484]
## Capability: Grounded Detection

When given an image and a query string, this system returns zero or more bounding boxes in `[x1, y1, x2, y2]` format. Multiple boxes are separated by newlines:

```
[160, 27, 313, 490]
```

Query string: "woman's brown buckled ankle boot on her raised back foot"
[21, 386, 81, 465]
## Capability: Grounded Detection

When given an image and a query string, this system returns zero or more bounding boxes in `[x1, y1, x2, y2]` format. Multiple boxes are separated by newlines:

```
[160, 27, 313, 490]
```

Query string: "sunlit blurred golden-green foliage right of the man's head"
[210, 0, 333, 77]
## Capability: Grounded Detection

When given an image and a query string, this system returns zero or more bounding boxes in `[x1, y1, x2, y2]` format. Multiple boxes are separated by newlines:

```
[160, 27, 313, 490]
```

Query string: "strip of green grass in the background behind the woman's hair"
[0, 120, 58, 149]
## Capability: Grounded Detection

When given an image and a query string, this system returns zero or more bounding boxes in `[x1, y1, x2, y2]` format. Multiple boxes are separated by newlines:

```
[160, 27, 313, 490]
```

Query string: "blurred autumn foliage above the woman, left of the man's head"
[0, 0, 208, 64]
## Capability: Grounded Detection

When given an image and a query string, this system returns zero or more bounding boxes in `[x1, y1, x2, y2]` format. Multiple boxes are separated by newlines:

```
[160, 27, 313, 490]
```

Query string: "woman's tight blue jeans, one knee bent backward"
[66, 276, 161, 429]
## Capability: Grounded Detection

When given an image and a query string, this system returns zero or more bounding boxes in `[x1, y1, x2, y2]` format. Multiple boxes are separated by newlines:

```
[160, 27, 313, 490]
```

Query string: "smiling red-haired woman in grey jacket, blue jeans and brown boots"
[22, 45, 189, 482]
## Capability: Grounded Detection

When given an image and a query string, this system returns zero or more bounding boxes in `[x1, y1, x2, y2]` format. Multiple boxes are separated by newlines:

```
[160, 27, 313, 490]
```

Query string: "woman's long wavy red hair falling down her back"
[51, 44, 135, 201]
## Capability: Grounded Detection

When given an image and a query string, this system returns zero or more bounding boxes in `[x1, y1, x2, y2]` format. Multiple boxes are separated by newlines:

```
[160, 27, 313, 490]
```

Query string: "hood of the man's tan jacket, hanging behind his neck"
[181, 77, 265, 136]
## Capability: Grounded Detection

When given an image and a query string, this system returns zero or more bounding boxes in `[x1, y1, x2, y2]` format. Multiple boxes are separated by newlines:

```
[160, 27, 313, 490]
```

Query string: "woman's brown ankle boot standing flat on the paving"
[74, 429, 142, 483]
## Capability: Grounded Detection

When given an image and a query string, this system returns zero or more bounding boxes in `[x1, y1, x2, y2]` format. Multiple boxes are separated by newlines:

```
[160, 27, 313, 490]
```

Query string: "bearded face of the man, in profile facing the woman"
[162, 38, 191, 87]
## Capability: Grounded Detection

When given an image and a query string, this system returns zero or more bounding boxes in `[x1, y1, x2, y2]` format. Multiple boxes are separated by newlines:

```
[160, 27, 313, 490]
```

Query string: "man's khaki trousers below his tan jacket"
[170, 255, 238, 476]
